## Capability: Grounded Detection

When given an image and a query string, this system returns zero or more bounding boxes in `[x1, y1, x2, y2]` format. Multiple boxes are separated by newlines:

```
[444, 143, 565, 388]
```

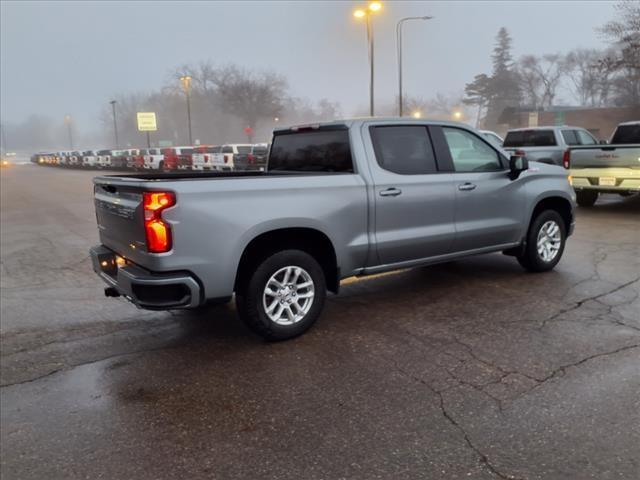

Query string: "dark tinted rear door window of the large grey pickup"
[371, 125, 437, 175]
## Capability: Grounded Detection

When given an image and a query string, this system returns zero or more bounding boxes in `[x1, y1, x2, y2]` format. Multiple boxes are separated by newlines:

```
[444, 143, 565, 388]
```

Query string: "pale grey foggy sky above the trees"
[0, 0, 614, 131]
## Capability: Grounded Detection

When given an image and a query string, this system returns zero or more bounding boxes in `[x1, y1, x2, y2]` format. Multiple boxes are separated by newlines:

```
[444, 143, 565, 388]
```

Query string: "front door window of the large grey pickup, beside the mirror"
[442, 127, 502, 172]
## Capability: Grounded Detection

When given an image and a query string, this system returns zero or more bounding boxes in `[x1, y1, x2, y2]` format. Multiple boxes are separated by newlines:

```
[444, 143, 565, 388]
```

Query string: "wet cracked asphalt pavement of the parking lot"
[0, 165, 640, 480]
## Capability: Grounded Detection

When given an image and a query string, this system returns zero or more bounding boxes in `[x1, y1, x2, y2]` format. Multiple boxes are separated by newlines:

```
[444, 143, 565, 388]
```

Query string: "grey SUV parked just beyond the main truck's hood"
[503, 125, 599, 165]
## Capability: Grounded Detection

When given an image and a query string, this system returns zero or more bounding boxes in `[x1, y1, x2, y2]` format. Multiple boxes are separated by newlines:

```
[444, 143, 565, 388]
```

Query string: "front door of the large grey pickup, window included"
[431, 127, 526, 252]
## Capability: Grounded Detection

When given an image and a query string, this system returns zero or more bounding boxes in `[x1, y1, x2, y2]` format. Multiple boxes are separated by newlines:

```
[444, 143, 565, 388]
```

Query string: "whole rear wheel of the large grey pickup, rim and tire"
[236, 250, 326, 341]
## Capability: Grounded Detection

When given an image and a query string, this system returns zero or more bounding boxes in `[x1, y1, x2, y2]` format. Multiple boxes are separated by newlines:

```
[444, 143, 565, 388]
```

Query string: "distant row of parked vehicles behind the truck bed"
[31, 143, 269, 171]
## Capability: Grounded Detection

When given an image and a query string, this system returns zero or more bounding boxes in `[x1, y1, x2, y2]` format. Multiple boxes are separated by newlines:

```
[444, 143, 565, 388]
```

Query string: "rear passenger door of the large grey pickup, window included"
[368, 123, 455, 265]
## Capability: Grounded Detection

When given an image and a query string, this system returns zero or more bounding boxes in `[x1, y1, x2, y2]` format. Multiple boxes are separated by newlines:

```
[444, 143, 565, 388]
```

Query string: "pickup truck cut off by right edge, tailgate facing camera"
[563, 121, 640, 207]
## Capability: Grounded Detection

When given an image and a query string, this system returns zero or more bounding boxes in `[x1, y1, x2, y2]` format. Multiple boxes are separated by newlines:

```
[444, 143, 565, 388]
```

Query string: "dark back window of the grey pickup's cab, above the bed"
[268, 128, 353, 173]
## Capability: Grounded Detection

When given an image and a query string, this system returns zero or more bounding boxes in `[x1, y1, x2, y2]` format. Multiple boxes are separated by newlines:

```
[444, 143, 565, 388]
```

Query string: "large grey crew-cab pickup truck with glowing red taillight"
[91, 118, 575, 340]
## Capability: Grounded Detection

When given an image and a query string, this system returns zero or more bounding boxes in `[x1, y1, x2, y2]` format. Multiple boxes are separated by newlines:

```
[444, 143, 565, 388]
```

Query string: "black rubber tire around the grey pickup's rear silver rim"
[236, 250, 327, 341]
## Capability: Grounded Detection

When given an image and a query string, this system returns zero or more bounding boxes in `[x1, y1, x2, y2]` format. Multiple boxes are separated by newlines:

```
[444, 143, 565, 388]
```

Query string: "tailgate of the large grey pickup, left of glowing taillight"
[94, 179, 146, 258]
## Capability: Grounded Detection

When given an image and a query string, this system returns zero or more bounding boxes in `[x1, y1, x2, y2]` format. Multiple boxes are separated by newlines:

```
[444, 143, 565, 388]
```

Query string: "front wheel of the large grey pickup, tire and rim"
[518, 210, 567, 272]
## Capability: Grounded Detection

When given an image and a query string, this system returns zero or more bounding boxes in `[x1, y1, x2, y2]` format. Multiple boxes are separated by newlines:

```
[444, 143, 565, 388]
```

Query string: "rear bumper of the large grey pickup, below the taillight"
[90, 245, 202, 310]
